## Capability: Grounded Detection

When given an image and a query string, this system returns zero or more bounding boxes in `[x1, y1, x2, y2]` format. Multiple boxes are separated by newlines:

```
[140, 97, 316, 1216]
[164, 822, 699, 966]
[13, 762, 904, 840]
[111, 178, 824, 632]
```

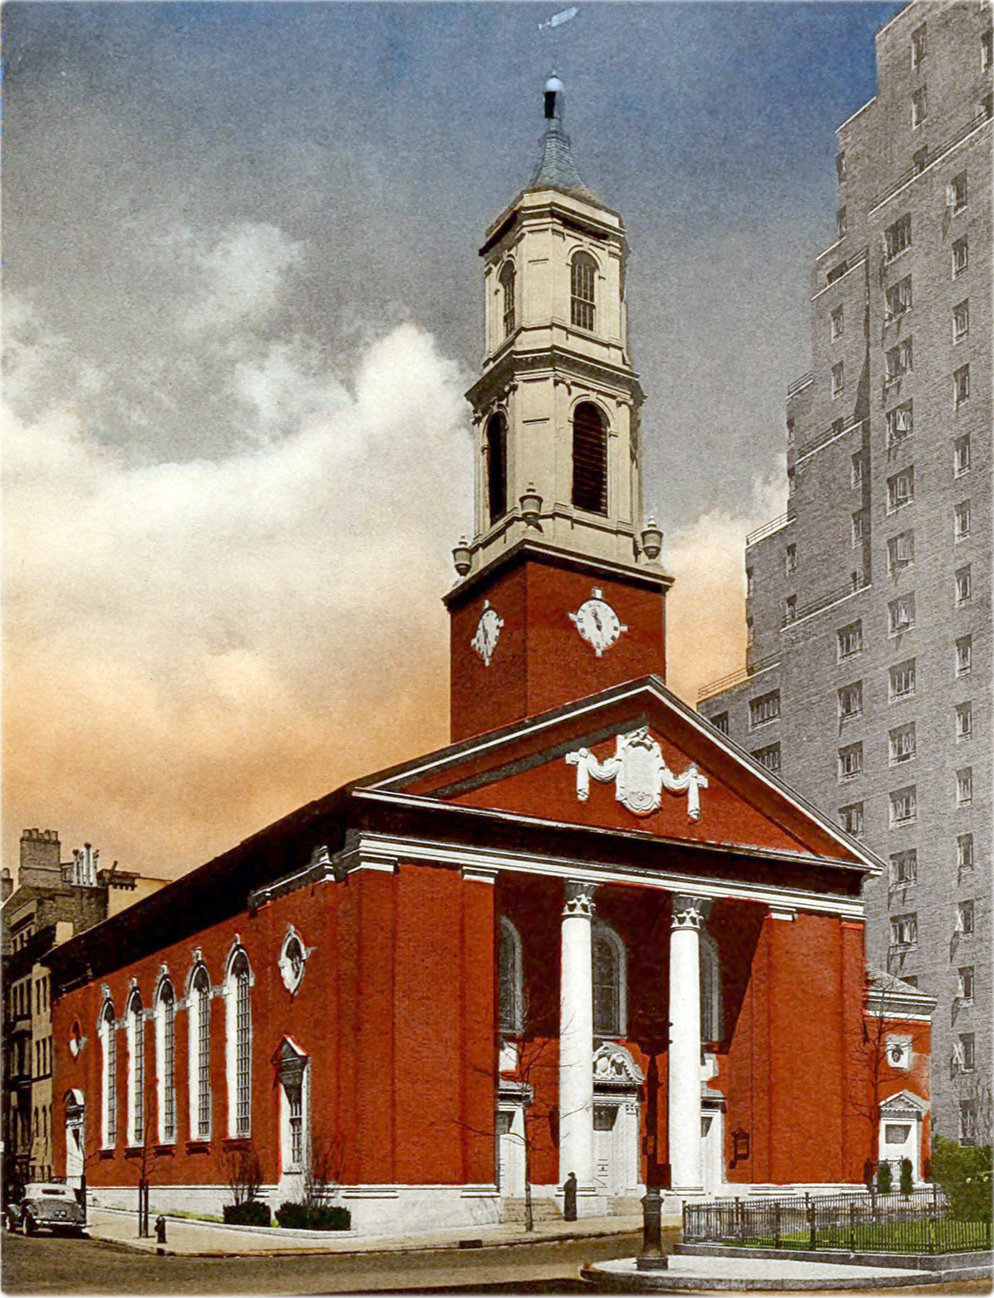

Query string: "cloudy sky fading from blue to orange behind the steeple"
[3, 0, 899, 876]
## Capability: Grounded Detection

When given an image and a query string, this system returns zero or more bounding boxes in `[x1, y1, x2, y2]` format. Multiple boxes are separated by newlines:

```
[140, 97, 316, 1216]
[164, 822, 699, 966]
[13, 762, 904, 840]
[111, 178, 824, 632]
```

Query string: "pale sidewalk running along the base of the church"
[79, 1207, 654, 1258]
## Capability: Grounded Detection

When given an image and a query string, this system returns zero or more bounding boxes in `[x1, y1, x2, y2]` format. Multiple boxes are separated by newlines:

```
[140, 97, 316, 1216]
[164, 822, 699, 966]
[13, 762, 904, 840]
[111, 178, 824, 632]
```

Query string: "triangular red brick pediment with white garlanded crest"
[361, 676, 881, 874]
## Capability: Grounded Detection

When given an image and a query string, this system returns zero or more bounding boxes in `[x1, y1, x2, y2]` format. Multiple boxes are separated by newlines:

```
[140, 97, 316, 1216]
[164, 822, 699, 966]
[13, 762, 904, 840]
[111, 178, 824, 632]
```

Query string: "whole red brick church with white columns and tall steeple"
[53, 80, 933, 1232]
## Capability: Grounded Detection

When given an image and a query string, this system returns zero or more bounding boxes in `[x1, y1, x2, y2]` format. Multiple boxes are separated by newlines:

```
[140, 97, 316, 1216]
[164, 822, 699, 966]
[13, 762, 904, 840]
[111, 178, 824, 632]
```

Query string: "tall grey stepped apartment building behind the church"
[698, 0, 993, 1141]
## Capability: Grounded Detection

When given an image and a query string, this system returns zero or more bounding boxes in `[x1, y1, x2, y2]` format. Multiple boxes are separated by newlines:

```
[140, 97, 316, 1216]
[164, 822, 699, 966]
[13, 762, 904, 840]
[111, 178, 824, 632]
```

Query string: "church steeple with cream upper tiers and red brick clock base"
[445, 77, 672, 739]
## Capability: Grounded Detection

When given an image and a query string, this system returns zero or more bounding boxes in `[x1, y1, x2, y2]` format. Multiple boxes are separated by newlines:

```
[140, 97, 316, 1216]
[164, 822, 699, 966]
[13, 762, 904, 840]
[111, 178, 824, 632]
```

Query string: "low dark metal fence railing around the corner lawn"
[684, 1185, 991, 1253]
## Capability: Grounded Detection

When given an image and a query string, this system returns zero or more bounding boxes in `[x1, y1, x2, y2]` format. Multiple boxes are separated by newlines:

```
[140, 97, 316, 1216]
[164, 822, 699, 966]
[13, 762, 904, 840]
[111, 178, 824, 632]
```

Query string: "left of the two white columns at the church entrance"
[559, 883, 596, 1211]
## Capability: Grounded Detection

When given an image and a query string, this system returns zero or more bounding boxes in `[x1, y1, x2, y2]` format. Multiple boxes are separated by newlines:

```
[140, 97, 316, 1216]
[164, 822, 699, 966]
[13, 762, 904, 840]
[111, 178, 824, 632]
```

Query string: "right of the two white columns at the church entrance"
[668, 894, 711, 1194]
